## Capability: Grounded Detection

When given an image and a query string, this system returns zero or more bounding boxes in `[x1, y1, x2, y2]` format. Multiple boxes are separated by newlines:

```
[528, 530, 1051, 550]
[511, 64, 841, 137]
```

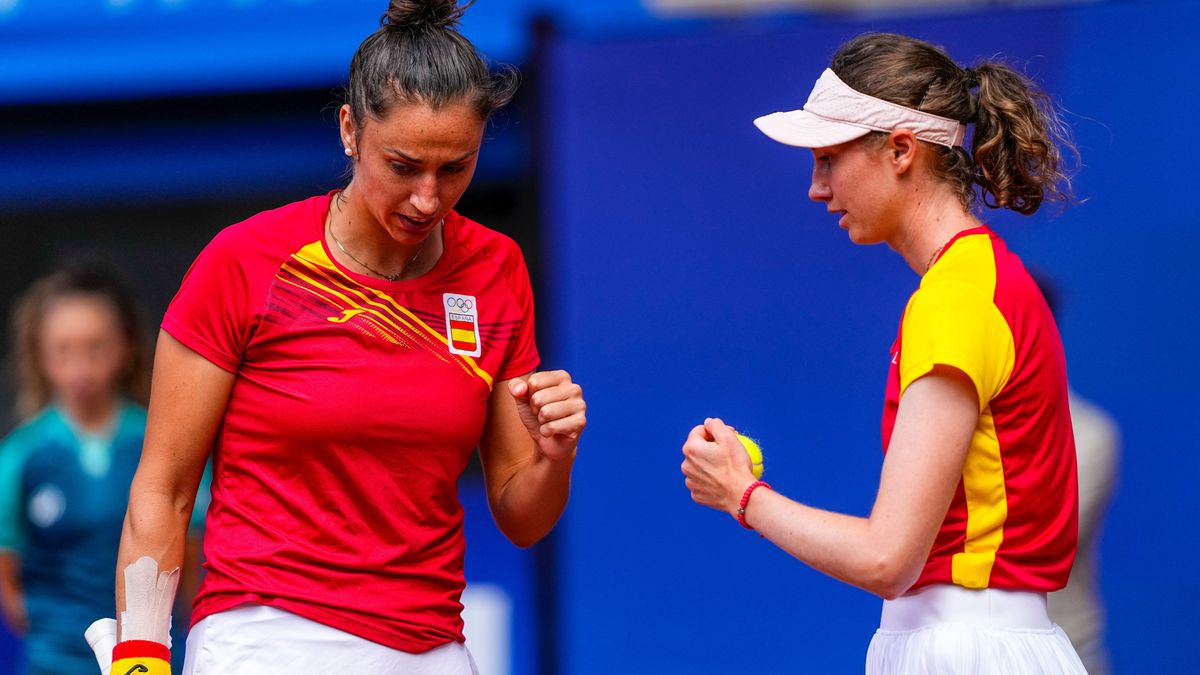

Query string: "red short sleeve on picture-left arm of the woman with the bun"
[162, 227, 254, 372]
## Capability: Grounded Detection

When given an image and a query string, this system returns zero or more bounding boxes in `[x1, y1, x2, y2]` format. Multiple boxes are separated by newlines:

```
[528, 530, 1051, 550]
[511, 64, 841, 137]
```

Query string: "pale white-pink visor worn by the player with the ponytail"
[754, 68, 967, 148]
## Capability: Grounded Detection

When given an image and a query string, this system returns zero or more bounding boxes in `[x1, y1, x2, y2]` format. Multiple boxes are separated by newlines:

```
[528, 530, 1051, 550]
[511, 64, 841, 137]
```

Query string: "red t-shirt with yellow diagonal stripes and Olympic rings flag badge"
[162, 196, 538, 652]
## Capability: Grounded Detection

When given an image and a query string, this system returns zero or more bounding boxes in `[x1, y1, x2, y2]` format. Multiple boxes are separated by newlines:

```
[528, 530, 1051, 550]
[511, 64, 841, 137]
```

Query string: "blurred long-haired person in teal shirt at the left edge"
[0, 263, 203, 674]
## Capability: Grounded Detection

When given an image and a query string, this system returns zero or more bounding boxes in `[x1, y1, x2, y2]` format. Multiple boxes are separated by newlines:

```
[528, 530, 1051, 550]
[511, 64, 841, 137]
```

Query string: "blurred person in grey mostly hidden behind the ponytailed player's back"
[1033, 273, 1121, 675]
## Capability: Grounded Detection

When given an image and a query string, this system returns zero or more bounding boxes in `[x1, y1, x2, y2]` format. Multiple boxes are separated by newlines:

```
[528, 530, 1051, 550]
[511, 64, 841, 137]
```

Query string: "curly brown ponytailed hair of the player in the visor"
[829, 32, 1078, 215]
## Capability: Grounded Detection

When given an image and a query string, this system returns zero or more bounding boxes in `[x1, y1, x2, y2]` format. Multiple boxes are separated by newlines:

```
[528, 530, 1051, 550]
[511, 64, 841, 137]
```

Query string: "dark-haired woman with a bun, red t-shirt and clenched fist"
[112, 0, 586, 675]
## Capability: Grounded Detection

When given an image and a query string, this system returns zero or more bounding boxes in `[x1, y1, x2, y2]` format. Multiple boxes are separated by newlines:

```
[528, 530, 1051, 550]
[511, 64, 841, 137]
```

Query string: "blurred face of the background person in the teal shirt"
[37, 294, 128, 430]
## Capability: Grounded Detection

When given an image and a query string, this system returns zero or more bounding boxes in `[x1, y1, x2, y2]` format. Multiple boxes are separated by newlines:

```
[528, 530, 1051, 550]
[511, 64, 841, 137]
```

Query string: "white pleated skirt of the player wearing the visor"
[866, 585, 1087, 675]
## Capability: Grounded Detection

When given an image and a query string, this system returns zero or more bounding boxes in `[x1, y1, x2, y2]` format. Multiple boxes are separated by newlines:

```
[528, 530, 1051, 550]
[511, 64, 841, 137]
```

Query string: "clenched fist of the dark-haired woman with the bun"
[509, 370, 587, 461]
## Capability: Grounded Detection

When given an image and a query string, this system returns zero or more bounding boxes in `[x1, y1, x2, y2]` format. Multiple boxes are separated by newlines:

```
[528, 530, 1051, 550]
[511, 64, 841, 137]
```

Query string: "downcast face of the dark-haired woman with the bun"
[329, 98, 485, 279]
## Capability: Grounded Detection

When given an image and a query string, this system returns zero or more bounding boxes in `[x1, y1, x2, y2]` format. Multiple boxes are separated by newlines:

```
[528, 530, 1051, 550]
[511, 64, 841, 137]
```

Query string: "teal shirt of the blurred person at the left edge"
[0, 402, 208, 674]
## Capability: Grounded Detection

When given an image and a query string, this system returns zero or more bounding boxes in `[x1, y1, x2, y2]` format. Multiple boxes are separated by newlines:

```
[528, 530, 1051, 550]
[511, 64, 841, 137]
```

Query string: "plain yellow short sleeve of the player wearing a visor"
[900, 281, 1015, 412]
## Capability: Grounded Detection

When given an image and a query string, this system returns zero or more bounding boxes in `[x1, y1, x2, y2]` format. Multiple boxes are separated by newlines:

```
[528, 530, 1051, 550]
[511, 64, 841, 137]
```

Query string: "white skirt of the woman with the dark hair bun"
[184, 604, 479, 675]
